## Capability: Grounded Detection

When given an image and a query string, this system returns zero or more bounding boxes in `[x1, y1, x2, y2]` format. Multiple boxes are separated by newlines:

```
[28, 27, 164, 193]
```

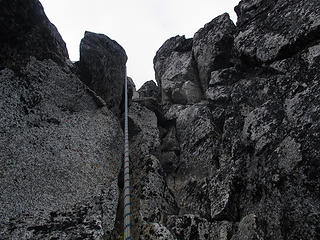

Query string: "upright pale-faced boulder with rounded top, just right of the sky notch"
[153, 36, 202, 104]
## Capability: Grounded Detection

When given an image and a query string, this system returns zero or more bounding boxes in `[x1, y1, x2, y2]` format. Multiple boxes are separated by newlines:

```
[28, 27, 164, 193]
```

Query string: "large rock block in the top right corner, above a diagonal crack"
[234, 0, 320, 64]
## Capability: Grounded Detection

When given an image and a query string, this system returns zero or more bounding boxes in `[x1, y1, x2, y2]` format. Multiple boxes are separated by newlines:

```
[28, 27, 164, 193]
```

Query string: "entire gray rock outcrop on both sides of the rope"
[0, 0, 320, 240]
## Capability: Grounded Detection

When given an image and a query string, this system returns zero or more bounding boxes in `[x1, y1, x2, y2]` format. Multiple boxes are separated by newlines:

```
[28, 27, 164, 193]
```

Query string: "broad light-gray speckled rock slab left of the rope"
[0, 58, 123, 239]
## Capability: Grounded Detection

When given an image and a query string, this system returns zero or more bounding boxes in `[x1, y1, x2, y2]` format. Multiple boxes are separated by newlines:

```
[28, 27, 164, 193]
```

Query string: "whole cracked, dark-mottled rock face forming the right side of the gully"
[146, 0, 320, 240]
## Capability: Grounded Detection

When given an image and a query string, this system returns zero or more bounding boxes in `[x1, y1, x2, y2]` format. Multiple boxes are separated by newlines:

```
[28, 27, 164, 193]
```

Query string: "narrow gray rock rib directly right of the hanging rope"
[125, 102, 177, 239]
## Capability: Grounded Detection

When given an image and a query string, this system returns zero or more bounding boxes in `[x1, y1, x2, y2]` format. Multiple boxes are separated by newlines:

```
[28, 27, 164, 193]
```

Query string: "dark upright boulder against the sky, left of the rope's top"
[79, 32, 127, 115]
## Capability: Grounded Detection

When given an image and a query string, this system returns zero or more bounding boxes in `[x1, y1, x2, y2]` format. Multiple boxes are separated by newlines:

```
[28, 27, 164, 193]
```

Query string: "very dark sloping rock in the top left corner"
[0, 0, 69, 69]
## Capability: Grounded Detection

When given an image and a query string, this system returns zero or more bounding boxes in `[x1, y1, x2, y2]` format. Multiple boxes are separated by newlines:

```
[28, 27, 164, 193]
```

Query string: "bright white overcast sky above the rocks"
[40, 0, 240, 88]
